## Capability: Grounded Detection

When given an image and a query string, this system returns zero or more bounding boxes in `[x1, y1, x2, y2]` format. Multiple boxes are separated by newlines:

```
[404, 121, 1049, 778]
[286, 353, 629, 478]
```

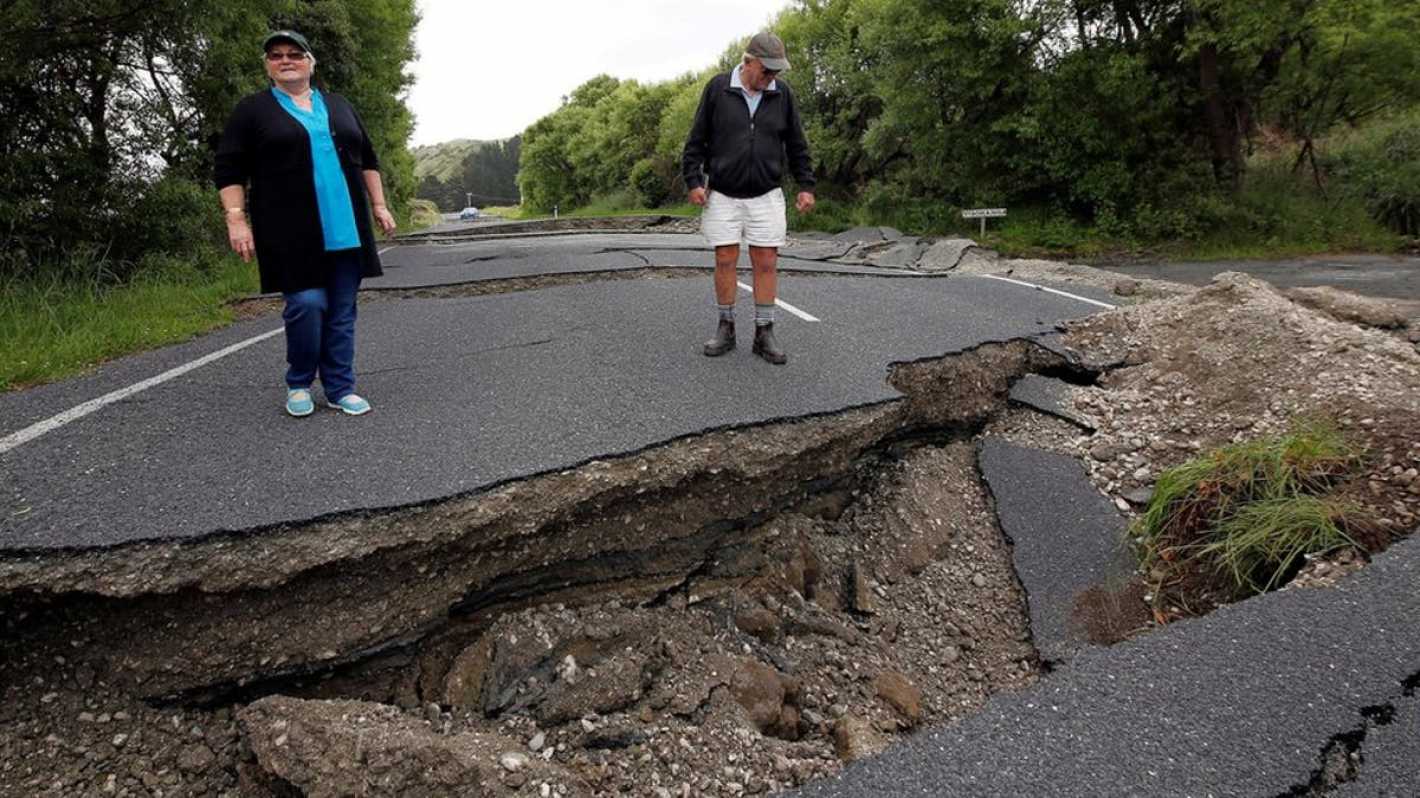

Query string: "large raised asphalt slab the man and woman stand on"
[0, 252, 1096, 552]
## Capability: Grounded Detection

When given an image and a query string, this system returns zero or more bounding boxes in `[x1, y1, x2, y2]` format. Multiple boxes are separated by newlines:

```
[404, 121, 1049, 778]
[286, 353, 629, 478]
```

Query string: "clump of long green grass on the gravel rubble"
[1133, 422, 1359, 596]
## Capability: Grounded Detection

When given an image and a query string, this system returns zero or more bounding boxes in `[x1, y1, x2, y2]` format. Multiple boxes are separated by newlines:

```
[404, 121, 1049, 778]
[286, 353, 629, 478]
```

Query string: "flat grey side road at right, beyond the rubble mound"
[1099, 256, 1420, 300]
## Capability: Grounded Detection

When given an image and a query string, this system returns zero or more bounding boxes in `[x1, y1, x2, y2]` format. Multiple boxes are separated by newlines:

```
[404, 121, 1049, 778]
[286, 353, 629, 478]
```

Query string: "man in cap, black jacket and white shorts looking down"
[682, 33, 814, 365]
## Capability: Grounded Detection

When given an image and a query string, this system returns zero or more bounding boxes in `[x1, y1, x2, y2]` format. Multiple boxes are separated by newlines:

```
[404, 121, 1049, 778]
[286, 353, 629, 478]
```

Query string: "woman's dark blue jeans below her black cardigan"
[281, 250, 361, 402]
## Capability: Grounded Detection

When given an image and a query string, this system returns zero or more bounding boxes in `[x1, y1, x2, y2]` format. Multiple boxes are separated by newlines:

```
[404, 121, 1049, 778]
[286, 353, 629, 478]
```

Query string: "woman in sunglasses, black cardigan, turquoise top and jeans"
[216, 30, 395, 416]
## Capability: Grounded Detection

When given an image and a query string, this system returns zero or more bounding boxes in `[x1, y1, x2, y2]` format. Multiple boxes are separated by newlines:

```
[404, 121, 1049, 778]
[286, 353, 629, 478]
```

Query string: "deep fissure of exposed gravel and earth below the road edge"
[0, 341, 1090, 795]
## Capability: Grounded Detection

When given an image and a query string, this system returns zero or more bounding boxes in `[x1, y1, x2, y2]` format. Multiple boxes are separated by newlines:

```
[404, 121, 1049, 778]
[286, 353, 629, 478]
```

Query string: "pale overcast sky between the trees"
[409, 0, 794, 145]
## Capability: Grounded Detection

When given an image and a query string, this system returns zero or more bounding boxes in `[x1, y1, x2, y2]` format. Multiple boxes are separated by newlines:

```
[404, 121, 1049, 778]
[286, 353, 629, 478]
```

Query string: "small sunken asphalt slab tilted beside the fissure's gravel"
[978, 437, 1135, 662]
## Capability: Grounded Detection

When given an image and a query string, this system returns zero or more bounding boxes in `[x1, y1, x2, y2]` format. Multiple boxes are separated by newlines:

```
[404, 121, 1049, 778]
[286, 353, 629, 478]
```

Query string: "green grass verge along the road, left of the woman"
[0, 253, 257, 390]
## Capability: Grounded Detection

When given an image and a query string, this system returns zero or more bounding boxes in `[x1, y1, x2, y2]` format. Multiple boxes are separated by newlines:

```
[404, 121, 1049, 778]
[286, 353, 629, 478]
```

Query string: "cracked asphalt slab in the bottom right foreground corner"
[795, 538, 1420, 798]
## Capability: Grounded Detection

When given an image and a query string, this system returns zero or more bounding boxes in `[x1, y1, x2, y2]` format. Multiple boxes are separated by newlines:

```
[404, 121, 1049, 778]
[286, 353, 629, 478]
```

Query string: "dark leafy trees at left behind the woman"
[0, 0, 417, 271]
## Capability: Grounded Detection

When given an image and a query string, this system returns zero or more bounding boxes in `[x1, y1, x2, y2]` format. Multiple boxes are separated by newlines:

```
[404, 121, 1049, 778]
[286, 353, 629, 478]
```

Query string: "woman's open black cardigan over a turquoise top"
[214, 89, 383, 294]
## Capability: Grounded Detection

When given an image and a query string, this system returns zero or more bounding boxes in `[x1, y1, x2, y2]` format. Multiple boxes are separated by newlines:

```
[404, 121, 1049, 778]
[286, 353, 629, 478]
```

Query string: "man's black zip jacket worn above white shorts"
[680, 72, 814, 199]
